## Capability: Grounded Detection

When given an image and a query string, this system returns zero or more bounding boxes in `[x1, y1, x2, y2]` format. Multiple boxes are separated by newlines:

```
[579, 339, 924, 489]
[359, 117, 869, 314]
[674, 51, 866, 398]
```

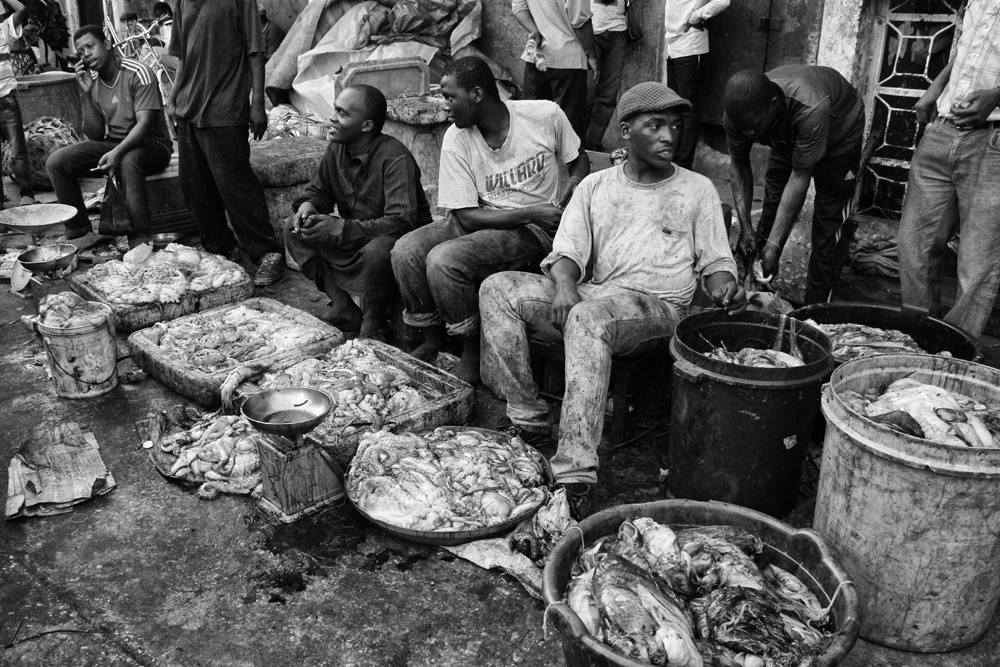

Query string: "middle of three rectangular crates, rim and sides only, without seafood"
[128, 297, 344, 408]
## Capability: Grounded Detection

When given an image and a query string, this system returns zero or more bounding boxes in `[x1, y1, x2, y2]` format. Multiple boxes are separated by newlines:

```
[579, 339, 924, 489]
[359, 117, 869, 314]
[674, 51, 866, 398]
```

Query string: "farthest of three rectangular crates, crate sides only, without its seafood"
[66, 272, 253, 333]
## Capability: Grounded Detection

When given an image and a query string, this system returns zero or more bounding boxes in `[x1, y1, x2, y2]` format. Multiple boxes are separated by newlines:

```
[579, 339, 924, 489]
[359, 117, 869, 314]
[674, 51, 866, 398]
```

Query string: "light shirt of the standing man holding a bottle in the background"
[511, 0, 590, 69]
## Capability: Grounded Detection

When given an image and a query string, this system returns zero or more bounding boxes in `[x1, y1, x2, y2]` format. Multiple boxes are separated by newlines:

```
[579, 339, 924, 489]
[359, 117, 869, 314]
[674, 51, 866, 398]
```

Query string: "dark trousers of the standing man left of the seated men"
[177, 118, 281, 263]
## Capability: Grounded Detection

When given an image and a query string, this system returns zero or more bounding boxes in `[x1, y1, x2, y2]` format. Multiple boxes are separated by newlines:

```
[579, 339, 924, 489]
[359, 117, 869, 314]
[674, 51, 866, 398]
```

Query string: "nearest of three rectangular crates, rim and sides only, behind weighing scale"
[240, 340, 476, 470]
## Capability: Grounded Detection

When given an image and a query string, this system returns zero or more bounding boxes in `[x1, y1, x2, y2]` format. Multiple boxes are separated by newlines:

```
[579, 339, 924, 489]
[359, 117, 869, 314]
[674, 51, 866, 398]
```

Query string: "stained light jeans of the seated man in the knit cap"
[479, 272, 680, 484]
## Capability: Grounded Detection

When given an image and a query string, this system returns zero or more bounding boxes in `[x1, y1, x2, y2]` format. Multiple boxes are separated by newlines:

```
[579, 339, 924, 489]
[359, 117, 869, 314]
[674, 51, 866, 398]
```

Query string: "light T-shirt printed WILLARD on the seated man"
[438, 100, 580, 250]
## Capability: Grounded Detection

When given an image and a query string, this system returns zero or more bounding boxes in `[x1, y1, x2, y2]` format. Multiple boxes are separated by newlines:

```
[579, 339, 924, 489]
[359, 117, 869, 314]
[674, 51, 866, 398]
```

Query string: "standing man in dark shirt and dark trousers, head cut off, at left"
[168, 0, 285, 286]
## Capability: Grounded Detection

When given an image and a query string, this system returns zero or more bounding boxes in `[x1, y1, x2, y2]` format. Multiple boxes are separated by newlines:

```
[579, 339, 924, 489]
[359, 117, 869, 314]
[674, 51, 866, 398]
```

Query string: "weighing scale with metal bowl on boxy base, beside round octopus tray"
[240, 387, 344, 523]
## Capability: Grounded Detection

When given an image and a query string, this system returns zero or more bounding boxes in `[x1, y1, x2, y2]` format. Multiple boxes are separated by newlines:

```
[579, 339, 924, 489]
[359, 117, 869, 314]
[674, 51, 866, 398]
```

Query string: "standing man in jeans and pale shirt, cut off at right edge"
[898, 0, 1000, 336]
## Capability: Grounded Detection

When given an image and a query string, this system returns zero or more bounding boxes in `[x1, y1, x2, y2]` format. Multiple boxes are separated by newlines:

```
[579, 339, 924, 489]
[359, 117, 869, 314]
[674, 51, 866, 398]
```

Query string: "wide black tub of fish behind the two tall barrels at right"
[790, 303, 983, 365]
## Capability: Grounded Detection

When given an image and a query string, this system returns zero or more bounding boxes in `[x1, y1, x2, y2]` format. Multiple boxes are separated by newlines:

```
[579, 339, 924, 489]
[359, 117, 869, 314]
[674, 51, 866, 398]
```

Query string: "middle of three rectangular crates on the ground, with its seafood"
[128, 298, 344, 407]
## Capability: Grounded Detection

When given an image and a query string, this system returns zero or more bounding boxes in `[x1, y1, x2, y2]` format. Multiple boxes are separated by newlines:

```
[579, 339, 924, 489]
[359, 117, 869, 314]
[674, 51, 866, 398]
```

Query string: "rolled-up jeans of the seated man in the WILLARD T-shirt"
[392, 215, 547, 338]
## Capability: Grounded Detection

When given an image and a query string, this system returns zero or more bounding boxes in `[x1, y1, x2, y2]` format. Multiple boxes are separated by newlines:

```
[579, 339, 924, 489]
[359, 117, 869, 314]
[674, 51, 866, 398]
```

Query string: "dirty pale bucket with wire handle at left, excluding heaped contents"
[36, 301, 118, 398]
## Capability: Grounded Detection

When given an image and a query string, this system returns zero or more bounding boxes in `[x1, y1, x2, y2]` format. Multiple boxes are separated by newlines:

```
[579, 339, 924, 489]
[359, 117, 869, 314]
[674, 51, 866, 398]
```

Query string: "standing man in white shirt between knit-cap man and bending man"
[663, 0, 729, 169]
